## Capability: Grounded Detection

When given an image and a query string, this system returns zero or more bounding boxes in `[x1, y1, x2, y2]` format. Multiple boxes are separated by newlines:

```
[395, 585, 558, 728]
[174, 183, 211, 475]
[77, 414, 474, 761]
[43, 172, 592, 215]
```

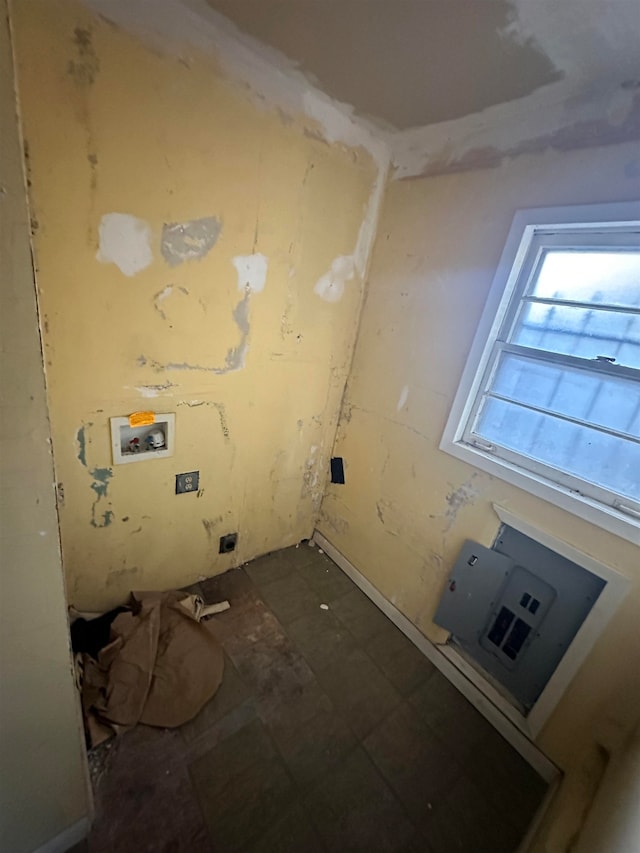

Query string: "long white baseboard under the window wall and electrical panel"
[313, 530, 561, 784]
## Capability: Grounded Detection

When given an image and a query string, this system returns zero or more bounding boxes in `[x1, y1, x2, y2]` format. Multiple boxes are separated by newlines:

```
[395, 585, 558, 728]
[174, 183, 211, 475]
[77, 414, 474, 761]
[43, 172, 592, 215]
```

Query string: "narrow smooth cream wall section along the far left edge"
[0, 0, 87, 853]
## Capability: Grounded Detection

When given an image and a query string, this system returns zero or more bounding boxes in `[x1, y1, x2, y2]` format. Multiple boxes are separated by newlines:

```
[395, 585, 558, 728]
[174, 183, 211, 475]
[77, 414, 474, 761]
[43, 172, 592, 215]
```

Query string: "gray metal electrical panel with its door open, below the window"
[435, 526, 605, 713]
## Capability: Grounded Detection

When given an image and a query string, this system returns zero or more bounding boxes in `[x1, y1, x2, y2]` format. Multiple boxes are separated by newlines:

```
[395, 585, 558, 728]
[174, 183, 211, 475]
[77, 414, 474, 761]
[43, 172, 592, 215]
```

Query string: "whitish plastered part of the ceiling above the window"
[388, 0, 640, 178]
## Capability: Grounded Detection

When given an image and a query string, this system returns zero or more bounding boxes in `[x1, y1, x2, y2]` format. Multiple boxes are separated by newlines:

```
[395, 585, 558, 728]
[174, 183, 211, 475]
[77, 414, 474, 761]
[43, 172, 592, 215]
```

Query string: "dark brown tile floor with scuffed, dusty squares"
[85, 544, 545, 853]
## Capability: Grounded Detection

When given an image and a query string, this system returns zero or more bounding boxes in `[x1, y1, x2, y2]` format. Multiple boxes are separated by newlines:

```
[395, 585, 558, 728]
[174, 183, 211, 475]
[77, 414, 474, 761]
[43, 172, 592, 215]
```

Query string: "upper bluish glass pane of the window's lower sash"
[491, 353, 640, 436]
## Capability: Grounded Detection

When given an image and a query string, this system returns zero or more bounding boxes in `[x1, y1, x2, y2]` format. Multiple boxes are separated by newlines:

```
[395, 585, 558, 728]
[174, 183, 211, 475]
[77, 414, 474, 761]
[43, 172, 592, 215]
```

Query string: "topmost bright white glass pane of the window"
[532, 250, 640, 308]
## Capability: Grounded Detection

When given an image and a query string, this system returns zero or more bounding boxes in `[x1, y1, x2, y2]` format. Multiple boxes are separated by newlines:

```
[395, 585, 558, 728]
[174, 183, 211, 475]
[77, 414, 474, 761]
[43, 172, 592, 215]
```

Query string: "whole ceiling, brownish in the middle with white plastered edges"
[84, 0, 640, 177]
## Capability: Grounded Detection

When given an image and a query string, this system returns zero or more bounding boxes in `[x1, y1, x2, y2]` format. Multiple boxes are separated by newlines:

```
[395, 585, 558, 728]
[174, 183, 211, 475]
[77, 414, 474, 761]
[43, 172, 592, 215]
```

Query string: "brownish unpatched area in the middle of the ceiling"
[207, 0, 562, 128]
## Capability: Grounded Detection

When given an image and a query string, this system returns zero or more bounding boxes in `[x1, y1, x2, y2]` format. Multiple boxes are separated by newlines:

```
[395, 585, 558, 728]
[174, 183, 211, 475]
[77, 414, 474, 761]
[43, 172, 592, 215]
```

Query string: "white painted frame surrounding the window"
[440, 201, 640, 544]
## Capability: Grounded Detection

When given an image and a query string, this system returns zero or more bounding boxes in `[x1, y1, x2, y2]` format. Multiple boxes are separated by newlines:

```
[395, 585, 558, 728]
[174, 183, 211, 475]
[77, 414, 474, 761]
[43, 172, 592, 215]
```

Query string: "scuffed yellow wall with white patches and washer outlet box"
[14, 0, 381, 609]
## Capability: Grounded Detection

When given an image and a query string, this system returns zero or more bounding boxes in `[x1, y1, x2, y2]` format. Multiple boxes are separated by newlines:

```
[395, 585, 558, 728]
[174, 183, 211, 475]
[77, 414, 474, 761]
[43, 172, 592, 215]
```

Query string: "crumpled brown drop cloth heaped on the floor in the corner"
[82, 592, 224, 745]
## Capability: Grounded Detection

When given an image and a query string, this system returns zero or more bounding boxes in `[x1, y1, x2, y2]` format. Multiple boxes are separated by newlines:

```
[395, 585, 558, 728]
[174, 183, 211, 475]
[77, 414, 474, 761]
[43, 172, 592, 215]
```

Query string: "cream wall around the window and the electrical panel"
[320, 144, 640, 853]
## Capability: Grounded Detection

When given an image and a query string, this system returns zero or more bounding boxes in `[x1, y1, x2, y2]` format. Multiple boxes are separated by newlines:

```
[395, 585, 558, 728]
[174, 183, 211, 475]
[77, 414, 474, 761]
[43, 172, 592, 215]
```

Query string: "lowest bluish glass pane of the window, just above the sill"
[474, 397, 640, 500]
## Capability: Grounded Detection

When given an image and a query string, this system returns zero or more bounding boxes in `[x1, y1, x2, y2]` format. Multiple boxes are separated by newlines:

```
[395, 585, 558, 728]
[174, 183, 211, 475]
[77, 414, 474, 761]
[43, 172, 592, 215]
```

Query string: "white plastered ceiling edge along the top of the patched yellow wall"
[84, 0, 390, 170]
